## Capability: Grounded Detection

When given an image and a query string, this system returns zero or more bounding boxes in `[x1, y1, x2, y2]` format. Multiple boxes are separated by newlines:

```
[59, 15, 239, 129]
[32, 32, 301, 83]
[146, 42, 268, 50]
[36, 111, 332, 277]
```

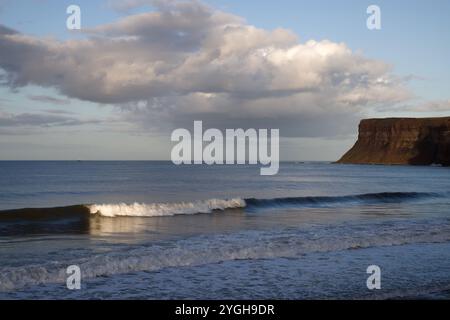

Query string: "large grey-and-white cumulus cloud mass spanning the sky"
[0, 1, 410, 136]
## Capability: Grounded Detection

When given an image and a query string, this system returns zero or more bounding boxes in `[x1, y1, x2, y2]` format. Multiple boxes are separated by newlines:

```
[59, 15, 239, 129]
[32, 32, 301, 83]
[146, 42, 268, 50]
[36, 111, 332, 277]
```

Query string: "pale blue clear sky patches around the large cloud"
[0, 0, 450, 160]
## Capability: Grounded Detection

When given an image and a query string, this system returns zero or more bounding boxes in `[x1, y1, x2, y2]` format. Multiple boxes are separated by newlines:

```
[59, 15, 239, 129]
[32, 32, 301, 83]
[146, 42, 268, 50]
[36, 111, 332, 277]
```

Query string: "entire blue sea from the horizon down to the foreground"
[0, 161, 450, 299]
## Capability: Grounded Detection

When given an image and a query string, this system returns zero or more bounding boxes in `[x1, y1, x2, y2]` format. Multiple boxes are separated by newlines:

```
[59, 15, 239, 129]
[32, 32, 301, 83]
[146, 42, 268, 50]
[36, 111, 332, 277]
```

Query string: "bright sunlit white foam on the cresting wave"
[88, 198, 246, 217]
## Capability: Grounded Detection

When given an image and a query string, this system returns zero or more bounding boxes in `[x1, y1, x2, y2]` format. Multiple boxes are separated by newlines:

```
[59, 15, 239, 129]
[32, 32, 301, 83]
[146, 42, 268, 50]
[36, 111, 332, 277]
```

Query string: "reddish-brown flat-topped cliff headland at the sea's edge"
[338, 117, 450, 166]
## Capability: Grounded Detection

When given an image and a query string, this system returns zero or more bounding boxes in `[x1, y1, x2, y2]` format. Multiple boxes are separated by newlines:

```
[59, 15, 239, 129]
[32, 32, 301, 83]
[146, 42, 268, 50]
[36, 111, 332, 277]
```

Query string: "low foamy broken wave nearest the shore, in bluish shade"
[0, 219, 450, 292]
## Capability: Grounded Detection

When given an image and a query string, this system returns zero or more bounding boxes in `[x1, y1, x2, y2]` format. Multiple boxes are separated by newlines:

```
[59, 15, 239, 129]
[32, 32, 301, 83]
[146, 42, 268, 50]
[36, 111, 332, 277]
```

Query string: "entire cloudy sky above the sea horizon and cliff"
[0, 0, 450, 161]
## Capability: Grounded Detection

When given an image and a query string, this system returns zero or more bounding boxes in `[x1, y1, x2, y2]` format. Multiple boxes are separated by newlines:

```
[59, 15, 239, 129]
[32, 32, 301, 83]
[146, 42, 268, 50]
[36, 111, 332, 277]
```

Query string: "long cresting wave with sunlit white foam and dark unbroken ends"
[0, 192, 446, 221]
